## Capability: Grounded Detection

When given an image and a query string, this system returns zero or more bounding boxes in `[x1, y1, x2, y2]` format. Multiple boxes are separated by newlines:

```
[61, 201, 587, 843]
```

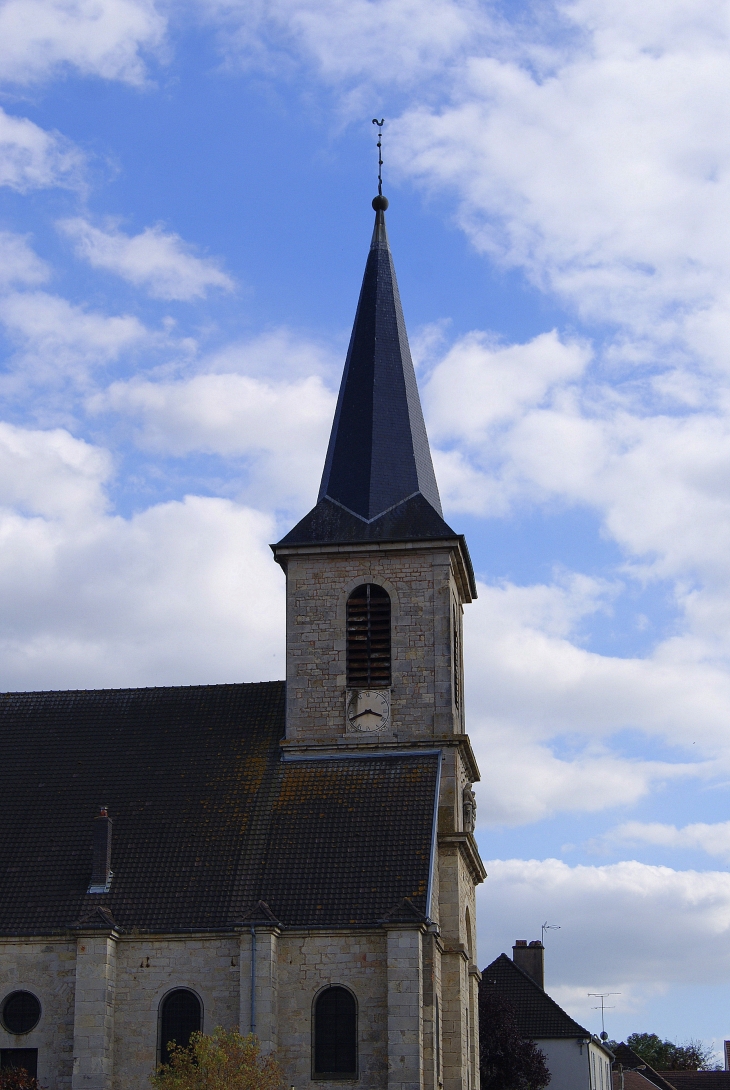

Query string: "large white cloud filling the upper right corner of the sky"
[385, 0, 730, 361]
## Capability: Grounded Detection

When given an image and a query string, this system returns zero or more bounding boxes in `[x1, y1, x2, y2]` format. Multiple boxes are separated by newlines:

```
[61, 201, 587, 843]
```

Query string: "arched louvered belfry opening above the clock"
[348, 583, 390, 689]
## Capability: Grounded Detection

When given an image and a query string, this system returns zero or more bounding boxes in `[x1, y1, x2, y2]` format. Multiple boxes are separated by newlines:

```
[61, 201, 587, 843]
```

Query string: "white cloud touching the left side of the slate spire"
[89, 361, 334, 507]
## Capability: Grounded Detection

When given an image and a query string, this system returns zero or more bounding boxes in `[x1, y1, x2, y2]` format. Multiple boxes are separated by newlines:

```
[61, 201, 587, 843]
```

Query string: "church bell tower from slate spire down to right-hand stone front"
[272, 196, 486, 1090]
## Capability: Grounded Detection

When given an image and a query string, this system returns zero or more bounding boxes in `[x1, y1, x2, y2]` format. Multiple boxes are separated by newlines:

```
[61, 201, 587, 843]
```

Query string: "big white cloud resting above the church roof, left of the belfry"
[0, 424, 283, 689]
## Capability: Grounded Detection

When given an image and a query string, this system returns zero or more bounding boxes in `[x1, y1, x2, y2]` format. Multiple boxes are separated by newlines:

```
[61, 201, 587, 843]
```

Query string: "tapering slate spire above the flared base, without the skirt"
[319, 197, 441, 522]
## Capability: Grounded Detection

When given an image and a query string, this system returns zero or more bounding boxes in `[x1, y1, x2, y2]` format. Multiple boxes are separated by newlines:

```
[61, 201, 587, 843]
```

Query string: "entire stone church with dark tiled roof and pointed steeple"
[0, 196, 486, 1090]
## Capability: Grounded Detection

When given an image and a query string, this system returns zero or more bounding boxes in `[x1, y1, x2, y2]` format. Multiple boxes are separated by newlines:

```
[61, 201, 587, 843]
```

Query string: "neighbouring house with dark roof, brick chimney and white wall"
[479, 940, 613, 1090]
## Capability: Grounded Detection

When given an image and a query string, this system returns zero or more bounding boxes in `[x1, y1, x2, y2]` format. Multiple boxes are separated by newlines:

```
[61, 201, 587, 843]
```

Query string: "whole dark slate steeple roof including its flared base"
[280, 196, 466, 545]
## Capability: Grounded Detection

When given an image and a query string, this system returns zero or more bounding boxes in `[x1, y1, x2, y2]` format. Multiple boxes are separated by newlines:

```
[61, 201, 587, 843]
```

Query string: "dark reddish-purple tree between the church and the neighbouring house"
[479, 985, 550, 1090]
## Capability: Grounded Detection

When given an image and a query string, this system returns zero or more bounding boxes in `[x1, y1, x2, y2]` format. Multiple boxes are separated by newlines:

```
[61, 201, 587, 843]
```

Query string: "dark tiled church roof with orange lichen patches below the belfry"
[0, 681, 438, 934]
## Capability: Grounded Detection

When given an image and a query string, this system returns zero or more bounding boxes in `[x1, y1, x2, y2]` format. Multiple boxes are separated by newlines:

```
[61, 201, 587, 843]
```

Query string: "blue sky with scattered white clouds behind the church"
[0, 0, 730, 1059]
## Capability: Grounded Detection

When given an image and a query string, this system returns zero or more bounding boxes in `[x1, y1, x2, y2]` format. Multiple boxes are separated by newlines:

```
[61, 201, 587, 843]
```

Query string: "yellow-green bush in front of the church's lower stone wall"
[151, 1027, 283, 1090]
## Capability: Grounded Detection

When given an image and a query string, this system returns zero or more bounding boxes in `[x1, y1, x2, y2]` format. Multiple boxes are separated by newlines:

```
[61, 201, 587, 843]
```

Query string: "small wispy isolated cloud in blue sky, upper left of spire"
[59, 217, 233, 300]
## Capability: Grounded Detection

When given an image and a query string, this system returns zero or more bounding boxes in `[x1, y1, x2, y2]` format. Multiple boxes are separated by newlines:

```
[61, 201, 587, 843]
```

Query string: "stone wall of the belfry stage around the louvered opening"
[287, 546, 461, 744]
